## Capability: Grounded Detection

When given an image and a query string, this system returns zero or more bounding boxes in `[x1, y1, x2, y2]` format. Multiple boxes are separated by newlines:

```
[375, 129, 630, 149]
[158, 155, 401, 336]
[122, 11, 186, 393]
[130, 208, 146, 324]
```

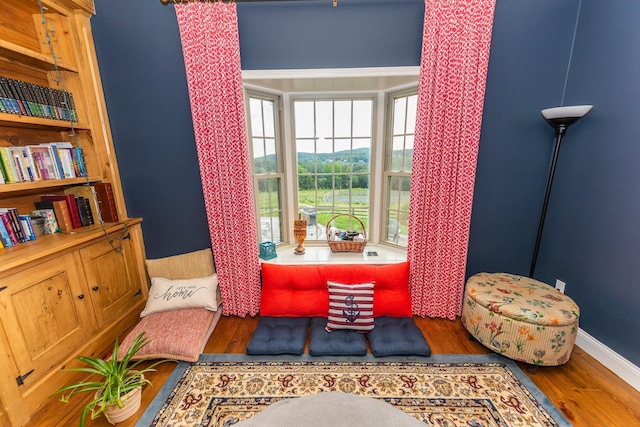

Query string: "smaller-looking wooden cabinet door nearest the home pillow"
[80, 233, 143, 327]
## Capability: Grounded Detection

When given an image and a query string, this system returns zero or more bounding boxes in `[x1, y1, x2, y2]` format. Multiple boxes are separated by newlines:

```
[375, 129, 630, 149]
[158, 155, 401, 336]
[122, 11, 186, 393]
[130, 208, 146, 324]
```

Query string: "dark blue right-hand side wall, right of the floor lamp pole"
[538, 0, 640, 365]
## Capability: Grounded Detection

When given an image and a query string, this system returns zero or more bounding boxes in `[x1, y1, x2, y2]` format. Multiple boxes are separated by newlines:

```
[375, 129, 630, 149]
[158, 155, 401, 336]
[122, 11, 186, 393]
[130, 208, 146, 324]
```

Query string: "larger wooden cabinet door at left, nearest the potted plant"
[0, 254, 95, 394]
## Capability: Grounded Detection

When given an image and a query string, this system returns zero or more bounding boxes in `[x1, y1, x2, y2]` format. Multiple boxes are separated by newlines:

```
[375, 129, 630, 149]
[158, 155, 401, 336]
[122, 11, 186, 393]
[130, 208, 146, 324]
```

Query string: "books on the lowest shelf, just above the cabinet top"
[0, 182, 118, 248]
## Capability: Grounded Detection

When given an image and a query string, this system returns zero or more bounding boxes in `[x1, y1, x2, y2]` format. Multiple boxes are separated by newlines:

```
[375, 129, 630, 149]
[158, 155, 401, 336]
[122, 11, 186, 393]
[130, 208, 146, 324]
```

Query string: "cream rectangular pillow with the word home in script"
[140, 274, 218, 317]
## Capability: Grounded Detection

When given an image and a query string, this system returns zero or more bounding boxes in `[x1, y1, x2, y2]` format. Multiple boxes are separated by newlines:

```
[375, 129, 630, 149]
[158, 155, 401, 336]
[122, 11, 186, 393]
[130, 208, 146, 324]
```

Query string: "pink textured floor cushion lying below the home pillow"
[118, 308, 222, 362]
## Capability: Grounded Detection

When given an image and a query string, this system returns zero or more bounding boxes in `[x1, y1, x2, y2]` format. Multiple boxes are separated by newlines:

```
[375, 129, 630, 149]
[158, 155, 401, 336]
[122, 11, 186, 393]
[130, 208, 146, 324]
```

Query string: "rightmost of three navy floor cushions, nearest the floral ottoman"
[367, 316, 431, 357]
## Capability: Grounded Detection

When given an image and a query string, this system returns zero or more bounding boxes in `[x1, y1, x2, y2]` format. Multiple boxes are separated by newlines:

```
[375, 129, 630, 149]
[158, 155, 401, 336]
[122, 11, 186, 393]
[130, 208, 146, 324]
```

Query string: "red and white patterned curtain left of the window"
[175, 2, 260, 317]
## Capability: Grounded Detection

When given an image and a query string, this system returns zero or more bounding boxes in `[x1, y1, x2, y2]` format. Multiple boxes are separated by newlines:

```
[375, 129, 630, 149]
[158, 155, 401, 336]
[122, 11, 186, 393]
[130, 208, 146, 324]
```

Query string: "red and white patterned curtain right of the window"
[407, 0, 495, 320]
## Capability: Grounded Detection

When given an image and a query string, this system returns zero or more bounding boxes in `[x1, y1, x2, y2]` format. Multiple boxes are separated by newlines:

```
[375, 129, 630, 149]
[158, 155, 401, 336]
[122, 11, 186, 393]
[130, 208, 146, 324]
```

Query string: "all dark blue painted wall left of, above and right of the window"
[92, 0, 640, 365]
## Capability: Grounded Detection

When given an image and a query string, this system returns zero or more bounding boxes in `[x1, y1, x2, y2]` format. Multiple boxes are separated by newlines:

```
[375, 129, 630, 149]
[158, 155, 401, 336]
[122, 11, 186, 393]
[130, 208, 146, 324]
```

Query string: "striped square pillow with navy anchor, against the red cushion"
[325, 281, 375, 333]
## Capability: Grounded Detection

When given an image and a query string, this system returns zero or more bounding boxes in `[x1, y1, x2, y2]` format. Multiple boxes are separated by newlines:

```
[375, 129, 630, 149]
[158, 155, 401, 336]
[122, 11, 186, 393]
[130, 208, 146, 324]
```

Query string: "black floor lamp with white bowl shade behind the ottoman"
[529, 105, 593, 278]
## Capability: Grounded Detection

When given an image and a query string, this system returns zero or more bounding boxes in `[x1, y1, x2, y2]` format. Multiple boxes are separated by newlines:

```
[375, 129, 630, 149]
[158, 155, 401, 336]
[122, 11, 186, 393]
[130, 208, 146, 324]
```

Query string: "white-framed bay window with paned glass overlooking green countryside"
[247, 71, 417, 247]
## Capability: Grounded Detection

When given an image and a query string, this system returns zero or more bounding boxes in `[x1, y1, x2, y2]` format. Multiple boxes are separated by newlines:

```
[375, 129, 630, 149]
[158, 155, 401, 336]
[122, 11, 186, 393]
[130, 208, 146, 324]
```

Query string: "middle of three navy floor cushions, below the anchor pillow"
[309, 317, 367, 356]
